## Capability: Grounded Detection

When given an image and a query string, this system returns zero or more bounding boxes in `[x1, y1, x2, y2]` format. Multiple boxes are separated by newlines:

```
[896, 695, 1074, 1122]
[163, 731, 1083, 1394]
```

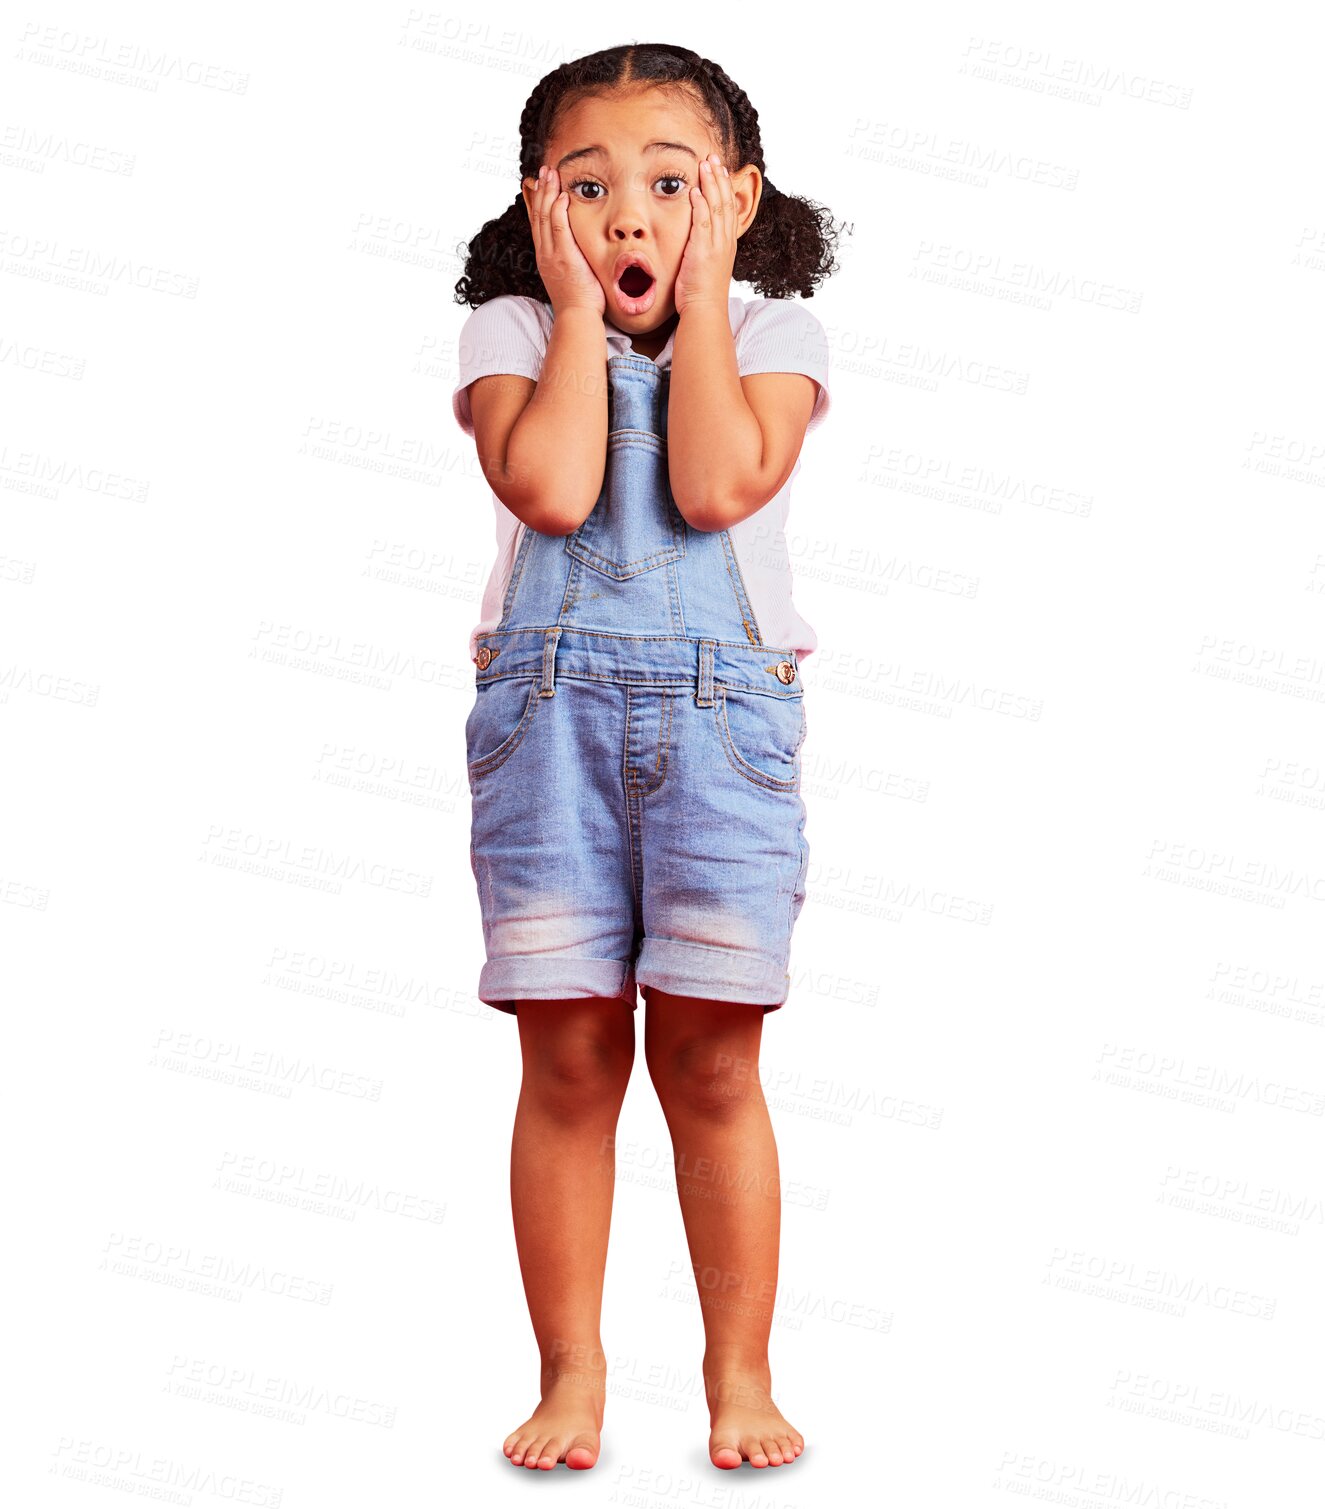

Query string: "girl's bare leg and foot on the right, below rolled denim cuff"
[644, 987, 804, 1467]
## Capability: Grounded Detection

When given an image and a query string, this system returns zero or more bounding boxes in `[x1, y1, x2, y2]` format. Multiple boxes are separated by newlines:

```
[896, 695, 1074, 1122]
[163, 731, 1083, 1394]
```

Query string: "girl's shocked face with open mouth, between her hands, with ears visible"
[525, 89, 762, 335]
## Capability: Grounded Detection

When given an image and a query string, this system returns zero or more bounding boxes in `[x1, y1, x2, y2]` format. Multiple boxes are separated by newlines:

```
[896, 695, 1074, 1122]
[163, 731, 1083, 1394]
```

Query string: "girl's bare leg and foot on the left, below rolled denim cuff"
[503, 997, 635, 1470]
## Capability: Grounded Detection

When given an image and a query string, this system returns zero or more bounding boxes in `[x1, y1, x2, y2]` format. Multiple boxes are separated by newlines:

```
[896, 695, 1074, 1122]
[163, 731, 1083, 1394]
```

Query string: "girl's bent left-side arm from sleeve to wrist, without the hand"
[469, 308, 607, 534]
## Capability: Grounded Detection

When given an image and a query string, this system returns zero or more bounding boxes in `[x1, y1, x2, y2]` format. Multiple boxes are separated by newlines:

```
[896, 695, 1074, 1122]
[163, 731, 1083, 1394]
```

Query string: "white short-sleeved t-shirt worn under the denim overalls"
[451, 293, 830, 659]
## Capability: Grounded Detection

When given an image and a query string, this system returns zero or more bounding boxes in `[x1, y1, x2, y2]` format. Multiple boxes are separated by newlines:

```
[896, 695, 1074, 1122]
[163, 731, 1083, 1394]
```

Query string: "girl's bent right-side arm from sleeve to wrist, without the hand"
[667, 303, 819, 530]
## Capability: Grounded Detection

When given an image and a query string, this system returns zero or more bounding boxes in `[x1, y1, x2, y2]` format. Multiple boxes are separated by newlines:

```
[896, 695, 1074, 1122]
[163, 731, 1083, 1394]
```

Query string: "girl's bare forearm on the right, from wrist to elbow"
[667, 305, 776, 530]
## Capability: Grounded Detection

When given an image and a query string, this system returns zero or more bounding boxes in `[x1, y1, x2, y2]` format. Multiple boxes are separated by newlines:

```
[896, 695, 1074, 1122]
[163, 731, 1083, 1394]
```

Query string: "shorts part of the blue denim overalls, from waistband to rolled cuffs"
[465, 625, 809, 1014]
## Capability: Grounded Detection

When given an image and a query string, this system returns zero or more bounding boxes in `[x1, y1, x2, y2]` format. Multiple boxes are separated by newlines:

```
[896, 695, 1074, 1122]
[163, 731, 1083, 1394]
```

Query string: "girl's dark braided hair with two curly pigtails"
[456, 42, 838, 308]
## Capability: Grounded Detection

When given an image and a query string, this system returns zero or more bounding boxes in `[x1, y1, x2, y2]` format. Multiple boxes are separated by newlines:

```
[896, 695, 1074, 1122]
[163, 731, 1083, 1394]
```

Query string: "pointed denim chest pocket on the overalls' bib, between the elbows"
[566, 430, 685, 581]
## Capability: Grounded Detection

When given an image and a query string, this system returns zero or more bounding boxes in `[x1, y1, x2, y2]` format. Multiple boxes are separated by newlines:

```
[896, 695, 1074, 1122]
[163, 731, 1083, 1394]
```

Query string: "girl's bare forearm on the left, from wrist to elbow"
[503, 308, 607, 534]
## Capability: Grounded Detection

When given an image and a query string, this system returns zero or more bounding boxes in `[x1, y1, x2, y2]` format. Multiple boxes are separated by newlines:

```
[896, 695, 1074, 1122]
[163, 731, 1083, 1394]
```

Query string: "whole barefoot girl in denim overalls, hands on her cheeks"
[454, 45, 835, 1468]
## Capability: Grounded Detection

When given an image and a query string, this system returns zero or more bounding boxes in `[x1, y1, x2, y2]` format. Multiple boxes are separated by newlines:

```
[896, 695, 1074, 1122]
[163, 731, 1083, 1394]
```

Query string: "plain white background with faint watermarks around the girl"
[0, 0, 1325, 1509]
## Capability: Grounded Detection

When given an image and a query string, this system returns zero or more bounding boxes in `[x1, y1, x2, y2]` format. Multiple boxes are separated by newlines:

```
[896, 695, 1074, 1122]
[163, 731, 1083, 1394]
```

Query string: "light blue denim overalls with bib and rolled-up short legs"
[465, 355, 809, 1013]
